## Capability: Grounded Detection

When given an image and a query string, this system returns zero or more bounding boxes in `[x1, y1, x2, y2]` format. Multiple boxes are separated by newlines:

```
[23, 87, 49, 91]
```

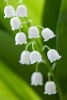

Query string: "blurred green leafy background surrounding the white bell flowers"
[0, 0, 67, 100]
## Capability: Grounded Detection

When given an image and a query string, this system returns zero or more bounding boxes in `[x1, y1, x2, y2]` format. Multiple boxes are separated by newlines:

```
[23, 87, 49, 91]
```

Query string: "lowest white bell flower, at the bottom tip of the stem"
[44, 81, 57, 95]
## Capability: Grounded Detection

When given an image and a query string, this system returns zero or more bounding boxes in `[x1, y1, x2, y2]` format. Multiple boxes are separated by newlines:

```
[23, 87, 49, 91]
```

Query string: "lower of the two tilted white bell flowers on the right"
[47, 49, 61, 63]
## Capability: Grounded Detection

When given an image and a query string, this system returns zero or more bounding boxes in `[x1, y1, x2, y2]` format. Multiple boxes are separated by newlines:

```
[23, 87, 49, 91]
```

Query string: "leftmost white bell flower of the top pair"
[4, 5, 15, 18]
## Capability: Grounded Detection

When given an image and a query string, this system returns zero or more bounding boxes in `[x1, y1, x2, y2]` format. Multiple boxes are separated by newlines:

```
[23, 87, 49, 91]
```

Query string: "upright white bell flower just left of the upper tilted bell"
[28, 26, 40, 38]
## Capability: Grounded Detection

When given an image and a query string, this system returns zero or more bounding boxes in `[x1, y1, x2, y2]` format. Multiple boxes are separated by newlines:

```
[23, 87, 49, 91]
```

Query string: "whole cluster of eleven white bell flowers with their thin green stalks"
[4, 0, 61, 95]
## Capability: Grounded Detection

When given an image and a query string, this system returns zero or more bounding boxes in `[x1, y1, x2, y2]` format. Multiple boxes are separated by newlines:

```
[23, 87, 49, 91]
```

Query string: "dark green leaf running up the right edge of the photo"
[56, 0, 67, 100]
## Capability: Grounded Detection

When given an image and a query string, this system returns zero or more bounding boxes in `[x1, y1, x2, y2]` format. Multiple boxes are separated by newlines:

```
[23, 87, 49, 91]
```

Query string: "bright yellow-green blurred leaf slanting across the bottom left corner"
[0, 61, 41, 100]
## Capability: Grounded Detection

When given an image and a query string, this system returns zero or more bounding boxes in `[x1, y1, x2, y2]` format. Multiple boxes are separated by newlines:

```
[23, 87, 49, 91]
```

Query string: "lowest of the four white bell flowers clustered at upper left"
[15, 32, 27, 45]
